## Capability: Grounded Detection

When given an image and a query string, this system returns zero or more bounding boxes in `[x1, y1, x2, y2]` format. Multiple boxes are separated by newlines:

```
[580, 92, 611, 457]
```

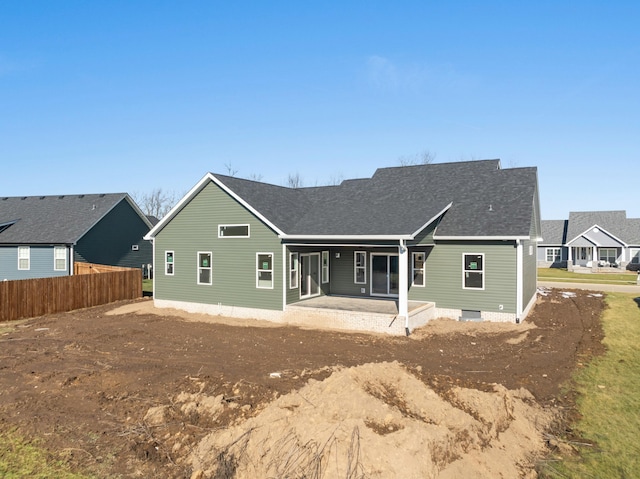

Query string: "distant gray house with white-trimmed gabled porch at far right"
[538, 211, 640, 270]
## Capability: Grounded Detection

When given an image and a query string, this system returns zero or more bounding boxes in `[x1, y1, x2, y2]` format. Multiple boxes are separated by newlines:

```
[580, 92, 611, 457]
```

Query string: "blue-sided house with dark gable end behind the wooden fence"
[0, 193, 152, 280]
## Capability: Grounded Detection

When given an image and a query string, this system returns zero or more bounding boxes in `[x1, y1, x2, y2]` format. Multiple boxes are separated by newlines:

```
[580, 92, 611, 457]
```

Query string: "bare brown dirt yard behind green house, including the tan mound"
[0, 290, 605, 479]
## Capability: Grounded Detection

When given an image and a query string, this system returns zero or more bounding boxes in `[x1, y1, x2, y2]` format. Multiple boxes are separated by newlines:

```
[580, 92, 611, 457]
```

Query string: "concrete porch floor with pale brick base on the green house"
[285, 295, 436, 335]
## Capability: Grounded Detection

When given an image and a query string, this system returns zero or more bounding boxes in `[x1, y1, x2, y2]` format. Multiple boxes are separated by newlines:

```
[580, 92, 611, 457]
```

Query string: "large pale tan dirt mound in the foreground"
[190, 362, 553, 479]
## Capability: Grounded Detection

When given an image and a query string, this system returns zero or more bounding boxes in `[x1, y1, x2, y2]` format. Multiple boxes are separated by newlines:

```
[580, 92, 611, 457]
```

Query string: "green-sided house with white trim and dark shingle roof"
[146, 160, 540, 333]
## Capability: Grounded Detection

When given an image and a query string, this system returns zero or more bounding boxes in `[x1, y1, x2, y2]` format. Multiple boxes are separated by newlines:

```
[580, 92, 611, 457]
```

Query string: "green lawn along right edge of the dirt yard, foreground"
[541, 293, 640, 479]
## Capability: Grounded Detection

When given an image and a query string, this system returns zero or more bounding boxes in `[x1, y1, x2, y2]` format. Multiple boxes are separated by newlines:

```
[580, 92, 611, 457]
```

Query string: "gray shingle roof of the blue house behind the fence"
[0, 193, 128, 244]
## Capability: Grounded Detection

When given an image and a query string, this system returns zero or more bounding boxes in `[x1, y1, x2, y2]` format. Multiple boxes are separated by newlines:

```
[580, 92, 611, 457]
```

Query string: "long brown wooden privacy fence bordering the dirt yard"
[0, 268, 142, 321]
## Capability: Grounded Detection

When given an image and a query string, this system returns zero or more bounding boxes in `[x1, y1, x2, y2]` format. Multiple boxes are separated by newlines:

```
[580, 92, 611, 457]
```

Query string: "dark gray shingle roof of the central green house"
[214, 160, 537, 237]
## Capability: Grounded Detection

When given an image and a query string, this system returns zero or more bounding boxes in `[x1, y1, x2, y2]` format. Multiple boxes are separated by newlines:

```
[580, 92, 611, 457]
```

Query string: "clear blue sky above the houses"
[0, 0, 640, 219]
